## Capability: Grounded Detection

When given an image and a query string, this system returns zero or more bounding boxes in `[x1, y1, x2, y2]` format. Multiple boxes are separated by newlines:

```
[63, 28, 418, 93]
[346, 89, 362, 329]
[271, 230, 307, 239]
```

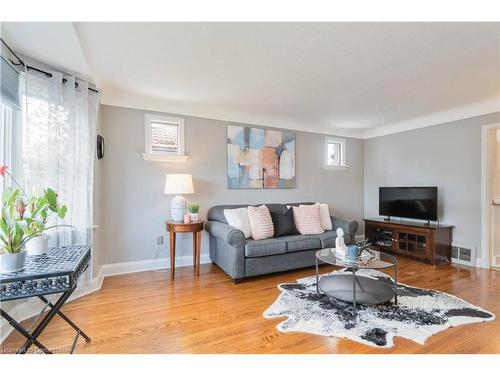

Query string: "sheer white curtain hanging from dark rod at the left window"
[23, 71, 99, 246]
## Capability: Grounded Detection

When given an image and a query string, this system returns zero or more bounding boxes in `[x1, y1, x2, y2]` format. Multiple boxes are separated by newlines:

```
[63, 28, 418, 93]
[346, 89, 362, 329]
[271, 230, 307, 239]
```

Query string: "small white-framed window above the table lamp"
[143, 114, 187, 162]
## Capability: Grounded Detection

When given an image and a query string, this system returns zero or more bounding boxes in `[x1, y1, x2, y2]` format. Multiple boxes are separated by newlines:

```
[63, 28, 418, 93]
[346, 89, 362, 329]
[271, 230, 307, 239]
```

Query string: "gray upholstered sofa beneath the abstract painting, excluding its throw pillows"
[205, 202, 358, 282]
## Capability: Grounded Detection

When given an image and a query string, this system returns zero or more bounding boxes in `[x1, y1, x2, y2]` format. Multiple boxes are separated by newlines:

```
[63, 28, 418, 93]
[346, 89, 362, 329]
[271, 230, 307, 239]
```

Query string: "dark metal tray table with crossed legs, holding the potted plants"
[0, 245, 91, 354]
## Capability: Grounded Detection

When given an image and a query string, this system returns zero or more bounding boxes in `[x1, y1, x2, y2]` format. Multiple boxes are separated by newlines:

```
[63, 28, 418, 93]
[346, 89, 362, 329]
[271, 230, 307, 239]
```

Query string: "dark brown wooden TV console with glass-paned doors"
[364, 219, 453, 265]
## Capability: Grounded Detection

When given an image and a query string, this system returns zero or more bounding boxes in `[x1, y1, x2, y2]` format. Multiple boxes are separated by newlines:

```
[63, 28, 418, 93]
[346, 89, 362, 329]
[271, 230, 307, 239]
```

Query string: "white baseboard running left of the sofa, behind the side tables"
[0, 253, 210, 343]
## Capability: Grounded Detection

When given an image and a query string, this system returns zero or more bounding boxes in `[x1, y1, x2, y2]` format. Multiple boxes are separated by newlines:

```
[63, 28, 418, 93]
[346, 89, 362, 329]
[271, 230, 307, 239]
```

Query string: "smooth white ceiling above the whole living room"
[2, 22, 500, 138]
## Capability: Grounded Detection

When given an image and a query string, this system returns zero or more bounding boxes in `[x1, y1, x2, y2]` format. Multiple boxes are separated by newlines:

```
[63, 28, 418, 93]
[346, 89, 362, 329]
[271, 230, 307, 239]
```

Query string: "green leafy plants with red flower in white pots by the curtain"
[0, 166, 71, 272]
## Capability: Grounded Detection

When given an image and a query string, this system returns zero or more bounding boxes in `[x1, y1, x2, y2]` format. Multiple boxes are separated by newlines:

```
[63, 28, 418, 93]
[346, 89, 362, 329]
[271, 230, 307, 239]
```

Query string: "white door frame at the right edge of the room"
[476, 122, 500, 268]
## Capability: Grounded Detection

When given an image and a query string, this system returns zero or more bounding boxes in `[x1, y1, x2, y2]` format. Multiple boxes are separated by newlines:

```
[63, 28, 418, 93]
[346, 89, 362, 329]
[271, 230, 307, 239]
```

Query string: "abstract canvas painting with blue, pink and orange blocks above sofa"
[227, 125, 295, 189]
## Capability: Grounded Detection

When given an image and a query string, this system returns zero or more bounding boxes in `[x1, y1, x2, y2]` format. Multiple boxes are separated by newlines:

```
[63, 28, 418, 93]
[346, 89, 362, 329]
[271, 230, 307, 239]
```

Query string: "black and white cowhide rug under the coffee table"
[264, 270, 495, 348]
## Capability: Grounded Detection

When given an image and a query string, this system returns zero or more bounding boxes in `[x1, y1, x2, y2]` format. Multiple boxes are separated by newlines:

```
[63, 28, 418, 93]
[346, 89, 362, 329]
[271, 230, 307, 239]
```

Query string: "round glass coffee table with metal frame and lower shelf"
[316, 248, 398, 314]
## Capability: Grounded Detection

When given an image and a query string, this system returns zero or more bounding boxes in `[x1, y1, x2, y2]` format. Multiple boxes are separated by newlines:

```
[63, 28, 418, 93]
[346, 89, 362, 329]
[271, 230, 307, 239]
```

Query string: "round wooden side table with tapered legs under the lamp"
[165, 220, 205, 279]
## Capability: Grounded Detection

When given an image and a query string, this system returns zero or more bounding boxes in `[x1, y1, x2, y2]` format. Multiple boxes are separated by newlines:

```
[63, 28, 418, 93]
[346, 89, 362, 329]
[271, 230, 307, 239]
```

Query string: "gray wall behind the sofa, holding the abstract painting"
[97, 106, 363, 264]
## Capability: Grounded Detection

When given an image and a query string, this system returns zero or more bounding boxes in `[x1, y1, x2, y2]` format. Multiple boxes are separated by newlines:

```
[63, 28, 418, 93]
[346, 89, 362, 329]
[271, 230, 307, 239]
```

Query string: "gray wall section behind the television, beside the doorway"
[364, 112, 500, 262]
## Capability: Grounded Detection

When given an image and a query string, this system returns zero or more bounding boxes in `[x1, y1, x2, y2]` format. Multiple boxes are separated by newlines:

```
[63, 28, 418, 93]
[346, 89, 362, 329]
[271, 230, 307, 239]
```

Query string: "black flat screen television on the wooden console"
[379, 186, 438, 221]
